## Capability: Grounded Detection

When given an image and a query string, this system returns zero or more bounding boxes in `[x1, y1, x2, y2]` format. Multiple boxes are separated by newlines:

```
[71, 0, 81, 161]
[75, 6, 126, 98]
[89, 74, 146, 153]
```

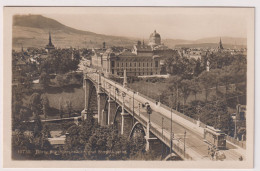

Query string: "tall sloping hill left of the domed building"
[13, 15, 137, 49]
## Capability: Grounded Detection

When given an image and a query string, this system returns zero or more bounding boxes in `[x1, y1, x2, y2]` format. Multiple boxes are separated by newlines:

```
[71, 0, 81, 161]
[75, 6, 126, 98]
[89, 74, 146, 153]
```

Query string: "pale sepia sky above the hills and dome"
[23, 7, 251, 40]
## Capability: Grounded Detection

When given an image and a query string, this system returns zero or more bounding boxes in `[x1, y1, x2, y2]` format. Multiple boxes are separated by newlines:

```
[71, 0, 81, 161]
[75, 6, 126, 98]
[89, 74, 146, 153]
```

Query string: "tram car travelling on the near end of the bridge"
[204, 126, 226, 149]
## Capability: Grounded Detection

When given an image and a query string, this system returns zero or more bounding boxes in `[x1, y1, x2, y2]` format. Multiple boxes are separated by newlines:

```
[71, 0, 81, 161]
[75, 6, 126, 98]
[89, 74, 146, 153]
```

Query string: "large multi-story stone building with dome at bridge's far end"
[91, 31, 176, 76]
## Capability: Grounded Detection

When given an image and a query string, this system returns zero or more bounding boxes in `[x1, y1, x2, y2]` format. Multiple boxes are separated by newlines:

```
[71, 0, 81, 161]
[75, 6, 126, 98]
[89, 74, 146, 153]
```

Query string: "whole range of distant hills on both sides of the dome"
[13, 15, 246, 49]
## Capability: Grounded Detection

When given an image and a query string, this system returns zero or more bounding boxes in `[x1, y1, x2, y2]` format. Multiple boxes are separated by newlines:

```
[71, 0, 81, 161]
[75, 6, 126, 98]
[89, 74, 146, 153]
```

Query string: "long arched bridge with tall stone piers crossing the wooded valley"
[82, 68, 245, 160]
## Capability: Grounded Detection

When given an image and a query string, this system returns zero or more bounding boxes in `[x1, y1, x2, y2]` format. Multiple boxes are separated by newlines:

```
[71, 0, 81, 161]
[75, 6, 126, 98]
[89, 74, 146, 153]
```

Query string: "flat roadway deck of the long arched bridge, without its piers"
[87, 69, 246, 160]
